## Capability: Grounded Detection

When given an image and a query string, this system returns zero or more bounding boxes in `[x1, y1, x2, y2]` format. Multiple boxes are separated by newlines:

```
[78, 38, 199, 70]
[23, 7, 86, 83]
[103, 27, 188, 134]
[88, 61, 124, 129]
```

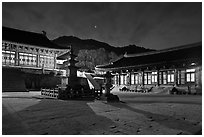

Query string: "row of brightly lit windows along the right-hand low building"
[113, 69, 195, 85]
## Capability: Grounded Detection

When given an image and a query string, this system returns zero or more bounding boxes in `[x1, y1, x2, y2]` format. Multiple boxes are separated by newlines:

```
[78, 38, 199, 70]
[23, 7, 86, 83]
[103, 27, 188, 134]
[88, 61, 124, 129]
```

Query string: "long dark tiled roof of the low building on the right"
[96, 42, 202, 69]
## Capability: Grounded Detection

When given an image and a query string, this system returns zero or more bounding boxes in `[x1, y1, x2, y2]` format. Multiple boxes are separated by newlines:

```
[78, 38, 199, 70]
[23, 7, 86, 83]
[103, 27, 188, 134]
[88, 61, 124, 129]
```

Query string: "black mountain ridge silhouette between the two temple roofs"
[52, 36, 153, 55]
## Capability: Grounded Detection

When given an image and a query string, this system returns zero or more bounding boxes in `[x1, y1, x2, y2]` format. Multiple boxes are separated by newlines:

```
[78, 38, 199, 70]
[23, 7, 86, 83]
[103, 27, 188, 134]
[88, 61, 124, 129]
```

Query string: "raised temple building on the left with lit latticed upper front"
[2, 27, 69, 91]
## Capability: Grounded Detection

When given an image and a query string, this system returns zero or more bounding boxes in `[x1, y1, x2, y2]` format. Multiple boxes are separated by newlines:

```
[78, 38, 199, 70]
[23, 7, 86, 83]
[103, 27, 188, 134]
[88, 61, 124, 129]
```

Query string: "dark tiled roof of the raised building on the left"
[2, 26, 67, 49]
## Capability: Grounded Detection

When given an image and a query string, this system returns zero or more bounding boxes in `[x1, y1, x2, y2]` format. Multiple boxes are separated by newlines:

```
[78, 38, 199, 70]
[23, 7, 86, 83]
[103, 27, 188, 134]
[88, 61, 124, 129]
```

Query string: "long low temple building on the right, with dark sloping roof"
[96, 42, 202, 93]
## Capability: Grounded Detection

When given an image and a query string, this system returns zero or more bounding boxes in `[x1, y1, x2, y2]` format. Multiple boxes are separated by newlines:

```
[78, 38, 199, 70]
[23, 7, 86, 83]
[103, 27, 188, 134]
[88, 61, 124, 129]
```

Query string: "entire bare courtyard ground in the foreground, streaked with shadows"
[2, 92, 202, 135]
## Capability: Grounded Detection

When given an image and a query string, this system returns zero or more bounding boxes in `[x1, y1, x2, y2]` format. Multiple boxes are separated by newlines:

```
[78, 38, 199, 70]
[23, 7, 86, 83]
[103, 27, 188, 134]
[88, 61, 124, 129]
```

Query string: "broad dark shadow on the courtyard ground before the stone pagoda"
[2, 99, 113, 135]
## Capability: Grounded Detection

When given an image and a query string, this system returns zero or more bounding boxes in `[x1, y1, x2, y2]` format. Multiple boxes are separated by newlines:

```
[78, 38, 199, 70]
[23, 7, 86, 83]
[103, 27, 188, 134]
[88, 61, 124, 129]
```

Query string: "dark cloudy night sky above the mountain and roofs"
[2, 2, 202, 49]
